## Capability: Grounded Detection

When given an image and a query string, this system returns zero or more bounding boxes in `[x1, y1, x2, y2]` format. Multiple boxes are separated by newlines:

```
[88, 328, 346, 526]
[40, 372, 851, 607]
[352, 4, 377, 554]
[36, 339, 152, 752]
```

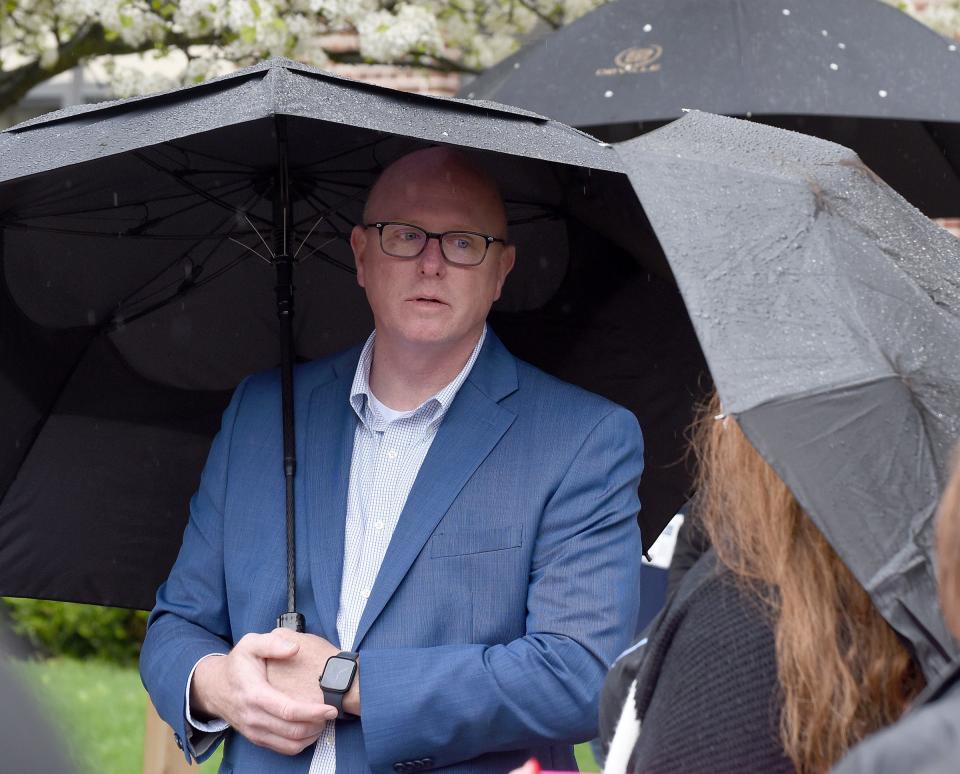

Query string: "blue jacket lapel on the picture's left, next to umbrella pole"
[300, 350, 359, 645]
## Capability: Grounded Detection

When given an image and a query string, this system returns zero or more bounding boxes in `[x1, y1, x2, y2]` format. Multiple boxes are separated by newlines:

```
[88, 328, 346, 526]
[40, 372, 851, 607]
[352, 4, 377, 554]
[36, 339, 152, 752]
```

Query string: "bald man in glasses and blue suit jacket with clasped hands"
[141, 148, 643, 774]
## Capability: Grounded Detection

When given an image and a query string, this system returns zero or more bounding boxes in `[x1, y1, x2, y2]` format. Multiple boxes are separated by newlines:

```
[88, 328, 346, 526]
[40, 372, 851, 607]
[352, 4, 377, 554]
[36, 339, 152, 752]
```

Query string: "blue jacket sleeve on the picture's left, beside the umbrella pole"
[140, 381, 247, 760]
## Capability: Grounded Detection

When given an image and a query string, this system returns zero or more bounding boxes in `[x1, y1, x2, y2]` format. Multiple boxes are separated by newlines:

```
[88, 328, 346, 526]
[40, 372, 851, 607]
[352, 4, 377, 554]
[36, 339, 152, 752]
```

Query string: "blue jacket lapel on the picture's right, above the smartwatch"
[350, 331, 517, 650]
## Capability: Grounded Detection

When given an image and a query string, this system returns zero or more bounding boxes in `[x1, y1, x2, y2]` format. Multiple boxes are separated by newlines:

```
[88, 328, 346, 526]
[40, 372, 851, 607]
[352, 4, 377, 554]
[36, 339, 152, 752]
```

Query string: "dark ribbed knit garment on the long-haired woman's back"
[600, 550, 794, 774]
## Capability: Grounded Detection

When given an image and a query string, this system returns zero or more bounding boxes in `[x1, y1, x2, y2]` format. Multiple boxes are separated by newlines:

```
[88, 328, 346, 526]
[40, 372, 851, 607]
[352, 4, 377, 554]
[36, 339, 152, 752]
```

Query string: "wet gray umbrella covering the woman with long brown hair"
[618, 113, 960, 677]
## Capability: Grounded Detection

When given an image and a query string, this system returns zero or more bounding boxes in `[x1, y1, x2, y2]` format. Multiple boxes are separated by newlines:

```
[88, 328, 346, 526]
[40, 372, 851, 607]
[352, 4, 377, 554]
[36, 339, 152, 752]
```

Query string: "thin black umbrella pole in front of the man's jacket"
[273, 116, 306, 632]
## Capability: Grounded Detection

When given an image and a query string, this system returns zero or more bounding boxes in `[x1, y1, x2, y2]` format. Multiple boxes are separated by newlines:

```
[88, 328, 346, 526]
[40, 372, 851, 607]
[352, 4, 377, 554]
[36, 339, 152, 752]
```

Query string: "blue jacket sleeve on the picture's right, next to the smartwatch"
[360, 408, 643, 773]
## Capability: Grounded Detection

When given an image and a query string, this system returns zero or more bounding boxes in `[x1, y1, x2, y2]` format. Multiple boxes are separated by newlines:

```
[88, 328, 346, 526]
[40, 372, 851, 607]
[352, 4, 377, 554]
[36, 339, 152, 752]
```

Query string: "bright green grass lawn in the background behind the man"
[11, 658, 598, 774]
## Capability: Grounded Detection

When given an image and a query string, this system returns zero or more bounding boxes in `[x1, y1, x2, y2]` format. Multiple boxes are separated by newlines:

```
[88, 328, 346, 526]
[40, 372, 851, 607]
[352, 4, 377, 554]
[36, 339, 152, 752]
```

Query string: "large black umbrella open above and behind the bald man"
[0, 61, 705, 612]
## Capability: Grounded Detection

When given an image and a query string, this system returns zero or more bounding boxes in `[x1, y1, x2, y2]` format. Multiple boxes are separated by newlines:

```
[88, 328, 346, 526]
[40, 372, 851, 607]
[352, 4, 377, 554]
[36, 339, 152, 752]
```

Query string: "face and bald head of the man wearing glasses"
[350, 148, 514, 358]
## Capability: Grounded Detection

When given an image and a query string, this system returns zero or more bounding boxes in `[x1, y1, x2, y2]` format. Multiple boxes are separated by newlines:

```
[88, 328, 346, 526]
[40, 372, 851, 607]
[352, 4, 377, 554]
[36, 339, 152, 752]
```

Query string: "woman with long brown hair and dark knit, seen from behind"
[601, 396, 923, 773]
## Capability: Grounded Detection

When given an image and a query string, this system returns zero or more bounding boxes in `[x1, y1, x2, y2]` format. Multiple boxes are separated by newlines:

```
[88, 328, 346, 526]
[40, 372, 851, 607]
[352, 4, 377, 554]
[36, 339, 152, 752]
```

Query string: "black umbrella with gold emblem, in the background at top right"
[462, 0, 960, 217]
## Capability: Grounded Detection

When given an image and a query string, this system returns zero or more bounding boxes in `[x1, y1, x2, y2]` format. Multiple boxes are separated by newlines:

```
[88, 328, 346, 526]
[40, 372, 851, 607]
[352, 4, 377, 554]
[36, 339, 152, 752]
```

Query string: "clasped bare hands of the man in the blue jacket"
[190, 629, 359, 755]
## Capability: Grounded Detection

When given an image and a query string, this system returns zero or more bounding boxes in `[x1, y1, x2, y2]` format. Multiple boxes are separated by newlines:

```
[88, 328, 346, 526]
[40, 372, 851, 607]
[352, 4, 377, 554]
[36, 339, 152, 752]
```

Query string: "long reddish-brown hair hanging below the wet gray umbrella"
[694, 394, 923, 773]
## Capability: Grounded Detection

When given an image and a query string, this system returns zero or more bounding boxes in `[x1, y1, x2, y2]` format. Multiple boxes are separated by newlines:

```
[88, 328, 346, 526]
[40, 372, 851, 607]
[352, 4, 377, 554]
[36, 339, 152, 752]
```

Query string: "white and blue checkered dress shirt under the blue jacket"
[310, 326, 487, 774]
